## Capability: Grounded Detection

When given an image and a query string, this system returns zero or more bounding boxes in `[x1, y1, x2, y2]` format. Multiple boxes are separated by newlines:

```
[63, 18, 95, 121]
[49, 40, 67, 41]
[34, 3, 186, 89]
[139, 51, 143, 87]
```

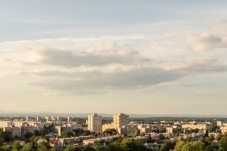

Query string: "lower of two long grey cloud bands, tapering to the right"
[30, 67, 183, 93]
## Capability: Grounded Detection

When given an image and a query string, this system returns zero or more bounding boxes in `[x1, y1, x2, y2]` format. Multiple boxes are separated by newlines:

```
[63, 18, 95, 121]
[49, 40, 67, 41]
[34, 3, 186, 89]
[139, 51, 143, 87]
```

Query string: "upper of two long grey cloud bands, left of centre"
[37, 49, 150, 67]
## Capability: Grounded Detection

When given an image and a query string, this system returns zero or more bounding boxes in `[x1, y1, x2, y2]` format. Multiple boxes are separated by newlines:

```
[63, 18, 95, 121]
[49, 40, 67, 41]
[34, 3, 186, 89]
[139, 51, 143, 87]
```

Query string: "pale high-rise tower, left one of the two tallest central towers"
[87, 114, 102, 133]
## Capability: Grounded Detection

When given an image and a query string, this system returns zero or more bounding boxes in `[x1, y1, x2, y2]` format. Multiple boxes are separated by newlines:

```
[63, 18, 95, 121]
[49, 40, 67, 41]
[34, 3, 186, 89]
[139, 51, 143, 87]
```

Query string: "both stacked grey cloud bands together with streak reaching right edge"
[24, 46, 227, 94]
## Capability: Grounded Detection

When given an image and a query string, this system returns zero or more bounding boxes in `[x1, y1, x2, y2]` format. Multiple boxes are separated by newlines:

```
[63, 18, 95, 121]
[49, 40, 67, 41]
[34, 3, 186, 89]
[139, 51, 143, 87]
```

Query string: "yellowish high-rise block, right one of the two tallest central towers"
[113, 113, 129, 128]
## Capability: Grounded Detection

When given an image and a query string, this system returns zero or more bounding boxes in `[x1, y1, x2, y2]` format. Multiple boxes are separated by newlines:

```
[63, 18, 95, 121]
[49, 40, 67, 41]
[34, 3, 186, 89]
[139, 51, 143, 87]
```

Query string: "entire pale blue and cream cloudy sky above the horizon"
[0, 0, 227, 115]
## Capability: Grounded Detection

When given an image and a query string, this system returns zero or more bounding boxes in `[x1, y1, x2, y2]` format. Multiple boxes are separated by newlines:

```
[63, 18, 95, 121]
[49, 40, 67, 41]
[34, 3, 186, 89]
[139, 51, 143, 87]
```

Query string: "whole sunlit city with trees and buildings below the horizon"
[0, 113, 227, 151]
